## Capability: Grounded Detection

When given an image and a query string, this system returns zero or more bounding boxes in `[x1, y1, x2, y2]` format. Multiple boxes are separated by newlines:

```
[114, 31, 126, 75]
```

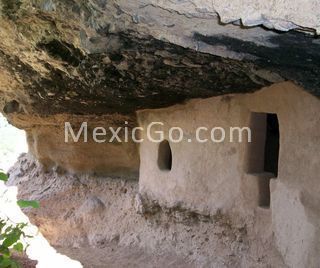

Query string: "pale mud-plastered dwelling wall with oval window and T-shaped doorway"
[138, 83, 320, 267]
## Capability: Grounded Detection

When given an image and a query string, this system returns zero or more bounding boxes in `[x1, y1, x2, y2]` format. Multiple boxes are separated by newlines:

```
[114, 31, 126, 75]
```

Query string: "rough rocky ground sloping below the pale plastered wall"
[9, 154, 284, 267]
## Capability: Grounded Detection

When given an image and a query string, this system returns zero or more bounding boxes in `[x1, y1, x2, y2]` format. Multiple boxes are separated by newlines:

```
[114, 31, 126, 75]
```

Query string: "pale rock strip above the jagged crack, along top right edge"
[146, 0, 320, 33]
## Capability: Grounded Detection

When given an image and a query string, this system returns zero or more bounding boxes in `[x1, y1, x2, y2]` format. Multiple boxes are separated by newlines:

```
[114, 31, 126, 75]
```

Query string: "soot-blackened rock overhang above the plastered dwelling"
[0, 1, 320, 118]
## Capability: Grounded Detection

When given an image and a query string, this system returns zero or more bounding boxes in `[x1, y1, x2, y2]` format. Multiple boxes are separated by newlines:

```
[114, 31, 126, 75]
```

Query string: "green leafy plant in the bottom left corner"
[0, 171, 39, 268]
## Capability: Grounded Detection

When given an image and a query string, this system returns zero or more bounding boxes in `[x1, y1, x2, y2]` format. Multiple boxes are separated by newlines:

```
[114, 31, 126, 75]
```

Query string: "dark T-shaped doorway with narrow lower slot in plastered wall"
[248, 113, 280, 207]
